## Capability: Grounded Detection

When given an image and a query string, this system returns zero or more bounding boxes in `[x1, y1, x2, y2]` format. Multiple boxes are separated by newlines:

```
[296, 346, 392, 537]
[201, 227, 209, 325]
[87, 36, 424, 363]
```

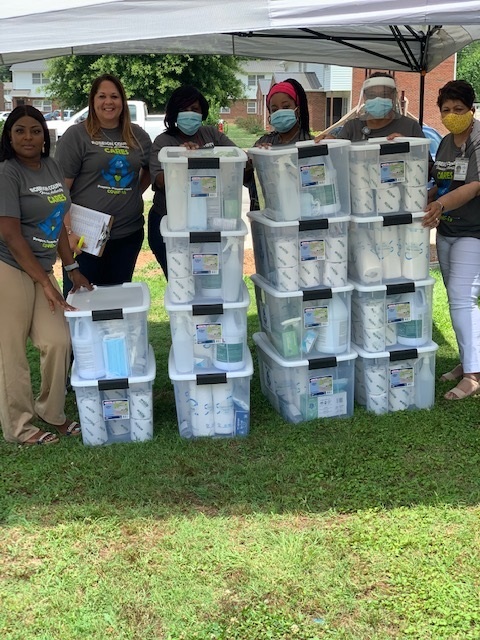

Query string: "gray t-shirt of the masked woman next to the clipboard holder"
[150, 125, 236, 217]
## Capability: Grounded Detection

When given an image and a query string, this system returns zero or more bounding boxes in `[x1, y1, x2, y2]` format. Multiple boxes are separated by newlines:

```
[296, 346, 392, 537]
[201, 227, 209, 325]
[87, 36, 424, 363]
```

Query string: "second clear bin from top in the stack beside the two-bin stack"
[160, 216, 248, 304]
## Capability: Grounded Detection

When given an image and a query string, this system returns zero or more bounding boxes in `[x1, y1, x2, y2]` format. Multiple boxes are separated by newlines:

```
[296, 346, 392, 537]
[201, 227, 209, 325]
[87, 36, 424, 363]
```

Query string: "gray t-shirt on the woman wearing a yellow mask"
[432, 120, 480, 238]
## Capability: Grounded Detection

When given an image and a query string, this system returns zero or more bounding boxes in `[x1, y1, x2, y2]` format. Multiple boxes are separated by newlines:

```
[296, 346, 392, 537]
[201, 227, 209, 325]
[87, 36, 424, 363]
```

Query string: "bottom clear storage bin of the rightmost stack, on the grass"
[353, 342, 438, 414]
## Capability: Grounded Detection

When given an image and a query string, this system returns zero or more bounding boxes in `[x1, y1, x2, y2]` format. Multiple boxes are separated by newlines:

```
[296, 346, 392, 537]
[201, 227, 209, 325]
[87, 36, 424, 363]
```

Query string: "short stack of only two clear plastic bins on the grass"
[65, 282, 155, 446]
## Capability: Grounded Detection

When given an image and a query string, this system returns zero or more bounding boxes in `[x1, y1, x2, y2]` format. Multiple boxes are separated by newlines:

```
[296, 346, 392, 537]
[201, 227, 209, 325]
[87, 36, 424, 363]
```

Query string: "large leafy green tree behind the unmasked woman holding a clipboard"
[48, 54, 243, 112]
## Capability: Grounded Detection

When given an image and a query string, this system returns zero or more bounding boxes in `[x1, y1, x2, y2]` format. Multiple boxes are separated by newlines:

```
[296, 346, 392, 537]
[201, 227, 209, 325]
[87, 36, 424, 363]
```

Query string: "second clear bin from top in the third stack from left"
[248, 210, 350, 291]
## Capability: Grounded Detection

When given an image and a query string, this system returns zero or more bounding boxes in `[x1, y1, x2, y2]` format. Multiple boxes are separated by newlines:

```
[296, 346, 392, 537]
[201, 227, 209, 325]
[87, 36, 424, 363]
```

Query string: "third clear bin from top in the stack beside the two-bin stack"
[165, 283, 250, 373]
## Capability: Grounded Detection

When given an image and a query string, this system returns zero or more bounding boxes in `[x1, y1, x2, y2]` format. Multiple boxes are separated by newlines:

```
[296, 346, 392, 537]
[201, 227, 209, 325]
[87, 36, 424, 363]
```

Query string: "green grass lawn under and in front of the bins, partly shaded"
[0, 263, 480, 640]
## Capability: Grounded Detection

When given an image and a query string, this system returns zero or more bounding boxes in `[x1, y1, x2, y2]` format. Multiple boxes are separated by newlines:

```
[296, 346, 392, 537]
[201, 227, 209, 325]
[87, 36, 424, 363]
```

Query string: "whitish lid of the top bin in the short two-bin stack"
[64, 282, 150, 318]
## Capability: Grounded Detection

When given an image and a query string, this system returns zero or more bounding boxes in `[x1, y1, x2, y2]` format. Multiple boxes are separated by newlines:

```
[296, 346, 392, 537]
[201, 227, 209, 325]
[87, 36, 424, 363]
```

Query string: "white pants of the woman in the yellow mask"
[437, 233, 480, 373]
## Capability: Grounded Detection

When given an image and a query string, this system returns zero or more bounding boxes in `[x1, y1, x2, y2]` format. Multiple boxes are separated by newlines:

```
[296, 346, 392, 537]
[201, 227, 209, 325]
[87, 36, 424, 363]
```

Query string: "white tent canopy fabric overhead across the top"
[0, 0, 480, 72]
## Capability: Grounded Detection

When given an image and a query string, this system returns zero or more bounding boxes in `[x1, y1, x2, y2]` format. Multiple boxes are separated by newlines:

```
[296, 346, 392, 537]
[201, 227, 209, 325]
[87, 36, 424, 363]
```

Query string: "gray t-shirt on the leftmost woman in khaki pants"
[0, 158, 70, 272]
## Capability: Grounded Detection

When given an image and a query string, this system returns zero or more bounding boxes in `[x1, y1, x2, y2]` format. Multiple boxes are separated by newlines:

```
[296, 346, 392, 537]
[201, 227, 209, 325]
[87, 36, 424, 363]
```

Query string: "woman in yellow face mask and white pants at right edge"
[424, 80, 480, 400]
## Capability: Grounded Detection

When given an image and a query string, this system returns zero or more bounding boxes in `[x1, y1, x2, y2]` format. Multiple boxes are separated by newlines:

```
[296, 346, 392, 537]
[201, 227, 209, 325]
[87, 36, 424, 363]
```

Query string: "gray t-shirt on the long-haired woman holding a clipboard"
[55, 123, 152, 239]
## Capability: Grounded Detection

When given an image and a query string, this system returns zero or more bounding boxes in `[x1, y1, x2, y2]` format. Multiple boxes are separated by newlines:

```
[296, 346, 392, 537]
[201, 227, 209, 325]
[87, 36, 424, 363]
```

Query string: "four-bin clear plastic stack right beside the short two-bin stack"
[159, 147, 252, 438]
